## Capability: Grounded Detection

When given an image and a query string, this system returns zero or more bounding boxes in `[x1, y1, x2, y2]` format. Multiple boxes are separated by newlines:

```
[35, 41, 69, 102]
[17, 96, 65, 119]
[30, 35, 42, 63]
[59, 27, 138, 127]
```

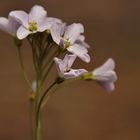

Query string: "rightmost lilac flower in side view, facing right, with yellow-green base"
[83, 58, 117, 91]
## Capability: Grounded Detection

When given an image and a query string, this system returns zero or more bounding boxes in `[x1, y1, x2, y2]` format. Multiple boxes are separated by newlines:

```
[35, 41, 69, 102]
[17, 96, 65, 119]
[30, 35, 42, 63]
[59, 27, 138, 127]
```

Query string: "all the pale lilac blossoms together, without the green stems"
[0, 5, 117, 91]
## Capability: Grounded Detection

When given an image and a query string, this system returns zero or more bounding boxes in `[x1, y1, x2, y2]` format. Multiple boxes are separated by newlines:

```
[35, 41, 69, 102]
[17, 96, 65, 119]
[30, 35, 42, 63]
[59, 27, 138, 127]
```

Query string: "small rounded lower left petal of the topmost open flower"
[17, 26, 30, 39]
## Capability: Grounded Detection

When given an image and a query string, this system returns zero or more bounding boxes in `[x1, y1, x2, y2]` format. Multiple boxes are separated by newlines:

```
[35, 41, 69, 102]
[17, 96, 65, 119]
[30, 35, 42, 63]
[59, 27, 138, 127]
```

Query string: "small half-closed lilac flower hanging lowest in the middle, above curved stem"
[54, 55, 87, 79]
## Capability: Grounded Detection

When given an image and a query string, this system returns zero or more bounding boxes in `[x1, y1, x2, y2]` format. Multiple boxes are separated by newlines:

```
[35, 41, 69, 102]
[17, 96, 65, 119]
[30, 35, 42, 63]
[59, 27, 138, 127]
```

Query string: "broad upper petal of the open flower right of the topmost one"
[64, 23, 84, 44]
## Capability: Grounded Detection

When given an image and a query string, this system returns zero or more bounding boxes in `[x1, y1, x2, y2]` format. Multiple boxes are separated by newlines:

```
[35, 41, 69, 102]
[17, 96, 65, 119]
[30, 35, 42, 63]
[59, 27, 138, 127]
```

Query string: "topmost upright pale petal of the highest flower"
[29, 5, 47, 23]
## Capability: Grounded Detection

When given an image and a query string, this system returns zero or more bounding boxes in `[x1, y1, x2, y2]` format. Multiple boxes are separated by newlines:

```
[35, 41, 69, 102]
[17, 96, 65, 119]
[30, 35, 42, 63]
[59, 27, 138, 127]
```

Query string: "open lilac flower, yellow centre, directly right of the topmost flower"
[51, 23, 90, 63]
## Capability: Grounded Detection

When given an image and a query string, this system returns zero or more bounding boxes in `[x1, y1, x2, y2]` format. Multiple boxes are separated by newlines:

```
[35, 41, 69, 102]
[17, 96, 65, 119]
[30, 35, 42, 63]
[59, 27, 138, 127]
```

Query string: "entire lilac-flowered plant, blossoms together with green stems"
[0, 5, 117, 140]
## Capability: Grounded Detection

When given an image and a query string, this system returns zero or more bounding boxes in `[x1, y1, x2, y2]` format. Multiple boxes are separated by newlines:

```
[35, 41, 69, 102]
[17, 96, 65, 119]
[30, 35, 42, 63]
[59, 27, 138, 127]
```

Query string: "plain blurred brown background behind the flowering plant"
[0, 0, 140, 140]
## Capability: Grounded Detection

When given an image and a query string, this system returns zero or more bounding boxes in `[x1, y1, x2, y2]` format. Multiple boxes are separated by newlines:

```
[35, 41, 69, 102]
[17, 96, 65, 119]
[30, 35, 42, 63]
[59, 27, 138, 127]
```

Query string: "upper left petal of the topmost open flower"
[9, 10, 28, 28]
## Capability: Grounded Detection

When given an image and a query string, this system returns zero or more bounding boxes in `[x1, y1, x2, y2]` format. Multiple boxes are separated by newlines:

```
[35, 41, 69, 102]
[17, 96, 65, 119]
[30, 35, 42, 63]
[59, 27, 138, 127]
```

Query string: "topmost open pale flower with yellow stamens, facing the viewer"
[11, 5, 61, 39]
